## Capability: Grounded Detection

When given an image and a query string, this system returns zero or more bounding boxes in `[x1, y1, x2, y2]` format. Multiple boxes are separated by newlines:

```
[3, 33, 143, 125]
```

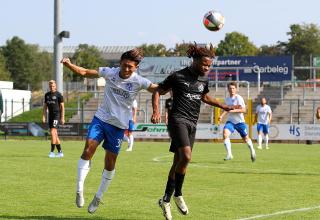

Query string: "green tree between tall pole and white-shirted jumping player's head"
[64, 44, 103, 81]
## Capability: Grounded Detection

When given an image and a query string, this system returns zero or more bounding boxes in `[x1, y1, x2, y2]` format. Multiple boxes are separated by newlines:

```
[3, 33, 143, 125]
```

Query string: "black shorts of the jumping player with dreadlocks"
[168, 120, 197, 153]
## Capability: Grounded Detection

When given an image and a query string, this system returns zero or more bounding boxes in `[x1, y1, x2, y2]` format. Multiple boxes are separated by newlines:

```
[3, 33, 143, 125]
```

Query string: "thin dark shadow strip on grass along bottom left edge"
[0, 215, 132, 220]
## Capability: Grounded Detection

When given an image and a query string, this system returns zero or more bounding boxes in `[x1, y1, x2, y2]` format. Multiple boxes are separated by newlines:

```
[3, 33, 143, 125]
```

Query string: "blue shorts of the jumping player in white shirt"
[87, 117, 124, 154]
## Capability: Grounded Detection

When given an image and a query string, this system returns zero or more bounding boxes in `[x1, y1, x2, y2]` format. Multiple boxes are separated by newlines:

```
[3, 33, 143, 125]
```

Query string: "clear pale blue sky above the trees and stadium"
[0, 0, 320, 48]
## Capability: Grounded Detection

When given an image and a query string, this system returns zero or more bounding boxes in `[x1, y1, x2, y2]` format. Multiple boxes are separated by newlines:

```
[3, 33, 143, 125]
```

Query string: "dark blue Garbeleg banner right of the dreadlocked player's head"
[209, 56, 292, 82]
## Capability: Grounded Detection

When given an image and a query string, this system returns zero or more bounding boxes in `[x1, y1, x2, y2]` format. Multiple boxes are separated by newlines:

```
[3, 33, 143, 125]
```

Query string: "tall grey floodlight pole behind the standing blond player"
[53, 0, 70, 94]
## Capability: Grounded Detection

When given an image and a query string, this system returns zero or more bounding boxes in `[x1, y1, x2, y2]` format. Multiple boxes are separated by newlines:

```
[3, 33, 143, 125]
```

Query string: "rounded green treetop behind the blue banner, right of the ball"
[216, 32, 258, 56]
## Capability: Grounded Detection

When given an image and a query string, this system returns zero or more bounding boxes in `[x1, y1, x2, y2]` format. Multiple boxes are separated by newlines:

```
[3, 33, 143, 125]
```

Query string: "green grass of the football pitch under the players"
[0, 140, 320, 220]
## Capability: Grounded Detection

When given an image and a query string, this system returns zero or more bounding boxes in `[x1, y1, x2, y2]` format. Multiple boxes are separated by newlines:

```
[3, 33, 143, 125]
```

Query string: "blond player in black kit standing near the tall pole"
[42, 80, 64, 158]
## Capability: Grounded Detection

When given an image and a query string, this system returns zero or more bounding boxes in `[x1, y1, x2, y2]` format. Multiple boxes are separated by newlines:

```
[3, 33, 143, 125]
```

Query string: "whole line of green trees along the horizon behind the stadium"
[0, 23, 320, 90]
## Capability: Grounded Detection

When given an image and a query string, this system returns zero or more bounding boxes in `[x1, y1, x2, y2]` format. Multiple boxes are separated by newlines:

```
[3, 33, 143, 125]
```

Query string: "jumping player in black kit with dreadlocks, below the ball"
[151, 44, 235, 219]
